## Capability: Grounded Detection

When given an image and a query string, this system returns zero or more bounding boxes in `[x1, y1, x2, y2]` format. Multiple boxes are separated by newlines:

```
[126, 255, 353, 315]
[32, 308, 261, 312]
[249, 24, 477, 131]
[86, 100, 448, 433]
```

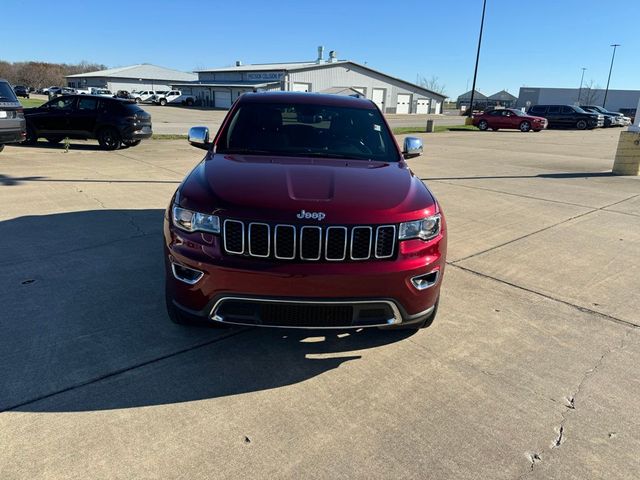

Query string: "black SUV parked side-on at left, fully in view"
[25, 95, 152, 150]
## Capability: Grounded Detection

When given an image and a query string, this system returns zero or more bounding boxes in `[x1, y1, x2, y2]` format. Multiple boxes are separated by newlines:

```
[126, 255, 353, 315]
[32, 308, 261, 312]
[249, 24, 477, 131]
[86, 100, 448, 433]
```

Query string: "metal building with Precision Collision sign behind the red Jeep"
[173, 47, 445, 113]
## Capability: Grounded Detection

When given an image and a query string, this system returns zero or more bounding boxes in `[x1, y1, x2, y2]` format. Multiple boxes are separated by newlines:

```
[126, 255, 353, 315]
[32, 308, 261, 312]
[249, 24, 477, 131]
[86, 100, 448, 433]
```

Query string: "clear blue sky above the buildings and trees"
[0, 0, 640, 97]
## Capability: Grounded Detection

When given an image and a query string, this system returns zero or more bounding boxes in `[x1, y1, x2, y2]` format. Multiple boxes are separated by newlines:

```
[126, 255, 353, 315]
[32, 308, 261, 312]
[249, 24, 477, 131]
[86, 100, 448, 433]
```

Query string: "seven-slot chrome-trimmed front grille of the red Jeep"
[222, 219, 397, 262]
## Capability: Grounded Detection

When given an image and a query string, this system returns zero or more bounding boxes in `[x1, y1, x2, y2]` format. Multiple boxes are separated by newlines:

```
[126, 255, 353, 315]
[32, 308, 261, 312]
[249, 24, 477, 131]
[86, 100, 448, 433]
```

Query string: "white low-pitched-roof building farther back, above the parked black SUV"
[66, 63, 198, 93]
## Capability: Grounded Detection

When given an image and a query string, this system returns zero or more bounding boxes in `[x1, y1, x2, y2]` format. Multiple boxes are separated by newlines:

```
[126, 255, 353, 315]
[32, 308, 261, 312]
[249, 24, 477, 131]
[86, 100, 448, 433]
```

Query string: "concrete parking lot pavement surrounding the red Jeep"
[0, 125, 640, 479]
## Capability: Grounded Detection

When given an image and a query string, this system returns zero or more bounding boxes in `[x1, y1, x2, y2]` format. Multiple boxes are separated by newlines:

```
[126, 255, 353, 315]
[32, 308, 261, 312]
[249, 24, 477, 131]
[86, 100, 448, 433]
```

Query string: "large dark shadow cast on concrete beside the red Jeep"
[0, 209, 413, 412]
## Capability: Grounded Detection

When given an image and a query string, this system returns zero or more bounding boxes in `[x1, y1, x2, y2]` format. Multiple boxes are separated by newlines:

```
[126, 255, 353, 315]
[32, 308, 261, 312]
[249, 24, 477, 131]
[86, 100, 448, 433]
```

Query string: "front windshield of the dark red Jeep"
[216, 103, 400, 162]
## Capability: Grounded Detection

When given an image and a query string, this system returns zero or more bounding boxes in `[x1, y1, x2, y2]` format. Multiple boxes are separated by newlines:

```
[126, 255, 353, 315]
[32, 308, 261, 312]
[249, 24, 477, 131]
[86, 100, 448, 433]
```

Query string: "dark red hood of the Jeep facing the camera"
[179, 154, 437, 224]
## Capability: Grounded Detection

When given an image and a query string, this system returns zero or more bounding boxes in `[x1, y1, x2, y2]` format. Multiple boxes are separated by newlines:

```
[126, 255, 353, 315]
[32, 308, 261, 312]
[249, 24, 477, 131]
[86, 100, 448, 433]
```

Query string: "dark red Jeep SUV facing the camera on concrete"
[164, 92, 446, 328]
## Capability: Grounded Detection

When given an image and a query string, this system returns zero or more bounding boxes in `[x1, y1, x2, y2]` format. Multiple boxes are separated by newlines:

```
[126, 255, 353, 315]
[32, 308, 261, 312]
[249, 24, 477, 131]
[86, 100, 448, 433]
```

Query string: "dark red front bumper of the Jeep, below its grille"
[164, 218, 446, 328]
